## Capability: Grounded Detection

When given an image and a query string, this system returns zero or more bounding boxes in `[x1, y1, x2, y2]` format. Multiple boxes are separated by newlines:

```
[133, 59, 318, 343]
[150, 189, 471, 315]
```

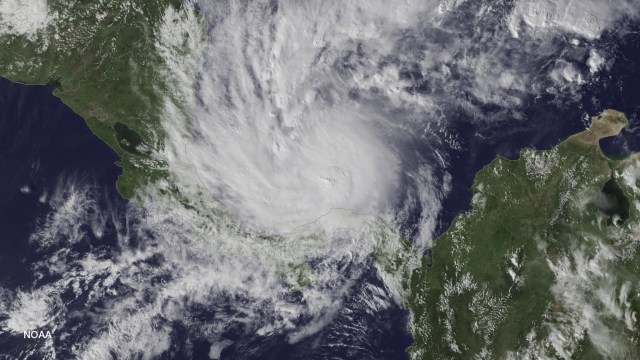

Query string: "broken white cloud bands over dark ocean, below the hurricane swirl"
[0, 178, 417, 359]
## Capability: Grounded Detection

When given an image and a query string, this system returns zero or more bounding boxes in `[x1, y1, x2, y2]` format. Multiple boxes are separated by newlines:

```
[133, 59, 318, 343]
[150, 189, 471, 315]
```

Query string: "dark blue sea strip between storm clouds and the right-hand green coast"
[436, 23, 640, 235]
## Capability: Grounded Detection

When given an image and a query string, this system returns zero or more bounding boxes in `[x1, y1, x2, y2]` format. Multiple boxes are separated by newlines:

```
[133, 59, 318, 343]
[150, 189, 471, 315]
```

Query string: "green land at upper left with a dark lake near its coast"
[0, 0, 180, 197]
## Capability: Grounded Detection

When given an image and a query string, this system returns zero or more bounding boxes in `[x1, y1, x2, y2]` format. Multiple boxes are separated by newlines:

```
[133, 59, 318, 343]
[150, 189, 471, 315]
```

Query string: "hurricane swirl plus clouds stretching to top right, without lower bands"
[158, 0, 633, 244]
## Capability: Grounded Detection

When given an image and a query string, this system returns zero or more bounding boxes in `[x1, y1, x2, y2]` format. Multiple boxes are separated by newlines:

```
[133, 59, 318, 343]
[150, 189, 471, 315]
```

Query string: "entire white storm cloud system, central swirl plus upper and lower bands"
[0, 0, 635, 358]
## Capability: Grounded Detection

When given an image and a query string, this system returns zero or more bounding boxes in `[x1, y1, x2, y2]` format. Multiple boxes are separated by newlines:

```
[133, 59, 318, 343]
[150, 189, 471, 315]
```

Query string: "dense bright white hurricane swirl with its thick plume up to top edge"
[162, 1, 448, 242]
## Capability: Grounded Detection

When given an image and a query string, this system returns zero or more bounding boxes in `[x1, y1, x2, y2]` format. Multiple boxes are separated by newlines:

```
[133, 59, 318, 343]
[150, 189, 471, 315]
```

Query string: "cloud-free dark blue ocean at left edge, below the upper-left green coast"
[0, 78, 120, 288]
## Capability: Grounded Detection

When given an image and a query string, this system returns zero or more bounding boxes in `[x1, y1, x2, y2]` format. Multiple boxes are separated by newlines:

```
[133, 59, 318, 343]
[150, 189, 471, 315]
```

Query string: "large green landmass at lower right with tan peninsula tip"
[409, 110, 640, 359]
